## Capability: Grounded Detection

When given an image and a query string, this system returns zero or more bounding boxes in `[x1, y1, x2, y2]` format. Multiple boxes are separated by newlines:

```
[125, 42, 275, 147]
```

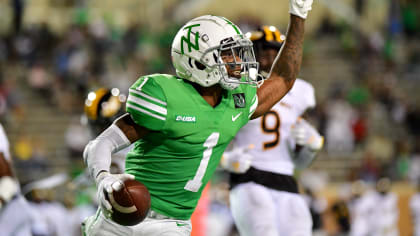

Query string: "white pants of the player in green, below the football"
[82, 210, 192, 236]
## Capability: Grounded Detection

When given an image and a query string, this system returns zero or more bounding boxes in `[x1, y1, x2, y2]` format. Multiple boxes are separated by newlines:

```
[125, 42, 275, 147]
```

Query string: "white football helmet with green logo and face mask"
[171, 15, 261, 90]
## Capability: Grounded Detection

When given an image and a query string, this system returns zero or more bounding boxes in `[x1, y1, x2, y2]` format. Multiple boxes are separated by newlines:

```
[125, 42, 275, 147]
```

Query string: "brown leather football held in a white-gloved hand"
[107, 179, 150, 226]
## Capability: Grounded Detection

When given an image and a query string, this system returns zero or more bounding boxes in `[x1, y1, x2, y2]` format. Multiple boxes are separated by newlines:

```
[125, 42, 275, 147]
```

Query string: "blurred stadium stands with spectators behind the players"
[0, 0, 420, 236]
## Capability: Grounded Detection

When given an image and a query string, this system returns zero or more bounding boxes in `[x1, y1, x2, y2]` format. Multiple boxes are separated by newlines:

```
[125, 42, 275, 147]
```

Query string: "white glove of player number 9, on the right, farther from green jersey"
[290, 118, 324, 151]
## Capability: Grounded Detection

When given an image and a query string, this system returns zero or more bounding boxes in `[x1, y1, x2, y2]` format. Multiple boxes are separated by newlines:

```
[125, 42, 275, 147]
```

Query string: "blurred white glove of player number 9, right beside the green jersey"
[220, 144, 254, 174]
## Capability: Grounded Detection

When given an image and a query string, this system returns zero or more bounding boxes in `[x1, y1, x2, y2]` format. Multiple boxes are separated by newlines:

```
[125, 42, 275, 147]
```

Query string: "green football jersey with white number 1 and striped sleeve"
[126, 74, 258, 220]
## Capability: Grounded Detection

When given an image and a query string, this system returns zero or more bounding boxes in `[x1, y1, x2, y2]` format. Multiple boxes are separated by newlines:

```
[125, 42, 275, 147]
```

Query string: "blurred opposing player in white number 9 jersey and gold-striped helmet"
[222, 26, 323, 236]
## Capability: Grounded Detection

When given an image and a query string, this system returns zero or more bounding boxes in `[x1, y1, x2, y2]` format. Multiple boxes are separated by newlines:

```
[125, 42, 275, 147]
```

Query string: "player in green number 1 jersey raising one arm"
[83, 0, 312, 235]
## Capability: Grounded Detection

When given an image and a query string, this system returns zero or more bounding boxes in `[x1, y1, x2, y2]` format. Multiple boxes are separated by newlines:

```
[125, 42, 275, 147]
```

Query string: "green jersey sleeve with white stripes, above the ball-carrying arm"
[126, 76, 167, 131]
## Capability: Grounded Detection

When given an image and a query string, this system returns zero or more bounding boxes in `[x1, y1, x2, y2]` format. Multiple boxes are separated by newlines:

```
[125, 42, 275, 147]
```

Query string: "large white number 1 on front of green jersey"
[184, 132, 220, 192]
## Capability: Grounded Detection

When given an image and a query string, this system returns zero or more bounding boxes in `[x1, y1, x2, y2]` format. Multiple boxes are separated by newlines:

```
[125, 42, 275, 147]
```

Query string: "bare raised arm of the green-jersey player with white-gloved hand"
[251, 0, 312, 119]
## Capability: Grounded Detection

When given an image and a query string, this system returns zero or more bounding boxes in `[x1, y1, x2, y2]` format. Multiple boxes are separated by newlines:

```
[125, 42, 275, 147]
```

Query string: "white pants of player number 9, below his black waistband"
[230, 182, 312, 236]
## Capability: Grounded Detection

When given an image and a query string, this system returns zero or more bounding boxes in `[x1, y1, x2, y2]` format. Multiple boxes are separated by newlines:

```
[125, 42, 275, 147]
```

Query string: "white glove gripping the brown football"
[96, 171, 134, 218]
